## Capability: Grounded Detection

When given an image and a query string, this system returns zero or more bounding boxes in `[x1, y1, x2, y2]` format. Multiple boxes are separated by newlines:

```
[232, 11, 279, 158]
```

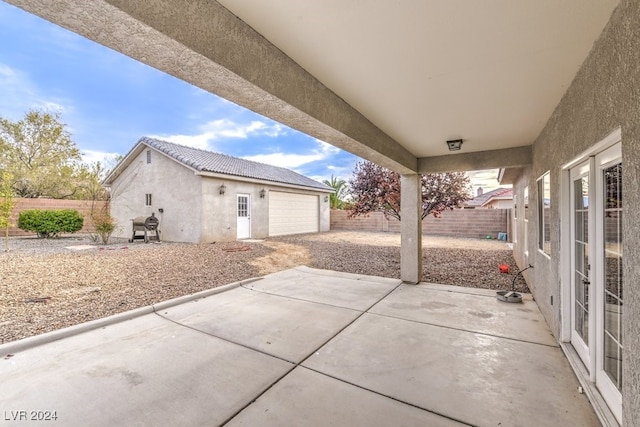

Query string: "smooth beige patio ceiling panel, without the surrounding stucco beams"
[220, 0, 618, 157]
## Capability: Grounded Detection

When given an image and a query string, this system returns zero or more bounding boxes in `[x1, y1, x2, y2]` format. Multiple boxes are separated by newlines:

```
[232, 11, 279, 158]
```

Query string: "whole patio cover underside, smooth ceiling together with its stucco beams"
[8, 0, 618, 173]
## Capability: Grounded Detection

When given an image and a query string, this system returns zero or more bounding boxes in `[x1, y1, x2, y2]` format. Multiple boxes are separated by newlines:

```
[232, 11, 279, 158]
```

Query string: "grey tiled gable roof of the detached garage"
[105, 137, 333, 192]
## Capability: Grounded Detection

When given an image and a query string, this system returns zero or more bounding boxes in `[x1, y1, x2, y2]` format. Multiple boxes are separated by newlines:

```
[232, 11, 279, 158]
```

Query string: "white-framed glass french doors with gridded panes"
[570, 144, 624, 421]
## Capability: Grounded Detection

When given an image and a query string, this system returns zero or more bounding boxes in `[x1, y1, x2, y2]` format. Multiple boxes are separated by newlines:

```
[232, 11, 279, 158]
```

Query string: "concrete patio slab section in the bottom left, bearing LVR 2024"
[0, 314, 293, 426]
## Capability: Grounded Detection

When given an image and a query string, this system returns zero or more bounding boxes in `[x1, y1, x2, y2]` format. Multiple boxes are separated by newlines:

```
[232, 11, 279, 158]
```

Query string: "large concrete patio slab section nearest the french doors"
[303, 314, 600, 427]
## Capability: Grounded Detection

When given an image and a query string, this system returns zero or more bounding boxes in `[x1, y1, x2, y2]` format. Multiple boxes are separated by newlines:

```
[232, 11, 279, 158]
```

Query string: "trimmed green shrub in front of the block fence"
[18, 209, 84, 238]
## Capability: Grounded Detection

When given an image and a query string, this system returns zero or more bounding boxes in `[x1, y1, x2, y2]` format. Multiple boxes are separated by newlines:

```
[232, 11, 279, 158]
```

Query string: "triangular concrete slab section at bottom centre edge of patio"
[227, 367, 464, 427]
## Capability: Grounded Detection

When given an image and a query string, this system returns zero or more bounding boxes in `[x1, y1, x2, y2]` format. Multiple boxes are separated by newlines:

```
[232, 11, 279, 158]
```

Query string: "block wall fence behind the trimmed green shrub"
[5, 198, 106, 237]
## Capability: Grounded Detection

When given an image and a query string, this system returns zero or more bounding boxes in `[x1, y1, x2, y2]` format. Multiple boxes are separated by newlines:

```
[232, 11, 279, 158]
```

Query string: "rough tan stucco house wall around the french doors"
[514, 0, 640, 426]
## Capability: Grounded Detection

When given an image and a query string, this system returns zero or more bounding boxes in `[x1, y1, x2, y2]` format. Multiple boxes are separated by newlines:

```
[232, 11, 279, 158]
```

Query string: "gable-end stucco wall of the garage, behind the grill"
[111, 149, 202, 243]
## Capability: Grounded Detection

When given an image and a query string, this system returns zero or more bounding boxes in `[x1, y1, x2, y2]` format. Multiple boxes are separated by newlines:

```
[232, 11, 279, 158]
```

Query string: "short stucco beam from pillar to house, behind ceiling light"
[418, 145, 532, 173]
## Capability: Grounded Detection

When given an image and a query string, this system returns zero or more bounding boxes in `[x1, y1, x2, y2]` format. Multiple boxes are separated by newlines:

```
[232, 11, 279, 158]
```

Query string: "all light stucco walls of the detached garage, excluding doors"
[111, 149, 330, 243]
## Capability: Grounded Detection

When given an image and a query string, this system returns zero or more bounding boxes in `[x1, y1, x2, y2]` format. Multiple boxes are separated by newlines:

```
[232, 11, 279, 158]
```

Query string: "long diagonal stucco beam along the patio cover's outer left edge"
[8, 0, 417, 173]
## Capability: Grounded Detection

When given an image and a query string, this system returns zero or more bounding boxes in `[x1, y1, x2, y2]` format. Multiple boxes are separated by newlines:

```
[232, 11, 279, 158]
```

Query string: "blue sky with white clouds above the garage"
[0, 1, 497, 192]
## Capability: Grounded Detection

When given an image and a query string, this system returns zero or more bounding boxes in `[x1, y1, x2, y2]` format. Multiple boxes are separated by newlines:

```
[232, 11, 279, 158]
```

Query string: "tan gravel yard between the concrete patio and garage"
[0, 231, 528, 343]
